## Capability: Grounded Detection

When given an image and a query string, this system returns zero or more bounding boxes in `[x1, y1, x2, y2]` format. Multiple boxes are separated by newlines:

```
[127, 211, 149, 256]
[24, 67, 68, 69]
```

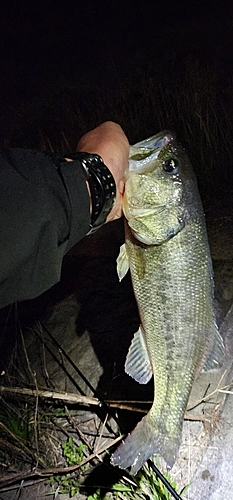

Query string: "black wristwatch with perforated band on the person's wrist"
[64, 152, 116, 234]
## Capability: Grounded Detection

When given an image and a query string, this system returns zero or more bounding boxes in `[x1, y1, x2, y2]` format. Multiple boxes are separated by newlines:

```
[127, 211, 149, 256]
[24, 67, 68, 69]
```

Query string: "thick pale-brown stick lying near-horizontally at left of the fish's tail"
[0, 386, 100, 406]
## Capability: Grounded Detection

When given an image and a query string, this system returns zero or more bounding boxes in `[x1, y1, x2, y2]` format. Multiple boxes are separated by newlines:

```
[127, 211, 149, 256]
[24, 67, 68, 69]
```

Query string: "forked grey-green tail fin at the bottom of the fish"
[111, 416, 180, 474]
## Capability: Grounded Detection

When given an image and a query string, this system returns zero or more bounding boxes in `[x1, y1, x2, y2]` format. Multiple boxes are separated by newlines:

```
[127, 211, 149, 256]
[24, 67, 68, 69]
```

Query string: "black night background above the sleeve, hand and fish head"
[0, 0, 233, 196]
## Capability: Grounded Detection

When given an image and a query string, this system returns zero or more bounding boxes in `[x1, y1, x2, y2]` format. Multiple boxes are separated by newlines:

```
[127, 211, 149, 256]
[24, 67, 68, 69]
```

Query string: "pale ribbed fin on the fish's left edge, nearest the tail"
[125, 326, 153, 384]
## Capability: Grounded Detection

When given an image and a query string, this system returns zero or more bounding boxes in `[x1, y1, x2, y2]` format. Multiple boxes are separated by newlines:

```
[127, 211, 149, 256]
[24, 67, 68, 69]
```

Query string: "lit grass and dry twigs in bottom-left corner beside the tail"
[0, 322, 186, 500]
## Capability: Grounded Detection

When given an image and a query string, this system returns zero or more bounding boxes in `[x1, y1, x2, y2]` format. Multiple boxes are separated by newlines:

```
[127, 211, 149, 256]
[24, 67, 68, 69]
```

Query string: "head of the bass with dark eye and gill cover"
[123, 132, 195, 245]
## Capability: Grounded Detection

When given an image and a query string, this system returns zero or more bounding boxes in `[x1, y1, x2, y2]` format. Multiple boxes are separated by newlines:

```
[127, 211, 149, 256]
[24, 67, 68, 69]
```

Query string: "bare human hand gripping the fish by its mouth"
[77, 121, 129, 222]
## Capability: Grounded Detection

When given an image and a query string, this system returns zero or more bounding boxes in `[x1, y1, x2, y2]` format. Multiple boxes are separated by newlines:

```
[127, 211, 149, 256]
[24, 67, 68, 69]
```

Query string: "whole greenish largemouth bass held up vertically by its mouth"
[111, 132, 224, 474]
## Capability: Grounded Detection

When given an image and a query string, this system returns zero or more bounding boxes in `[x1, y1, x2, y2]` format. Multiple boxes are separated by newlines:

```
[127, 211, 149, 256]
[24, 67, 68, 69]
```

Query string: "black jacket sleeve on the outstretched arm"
[0, 148, 90, 307]
